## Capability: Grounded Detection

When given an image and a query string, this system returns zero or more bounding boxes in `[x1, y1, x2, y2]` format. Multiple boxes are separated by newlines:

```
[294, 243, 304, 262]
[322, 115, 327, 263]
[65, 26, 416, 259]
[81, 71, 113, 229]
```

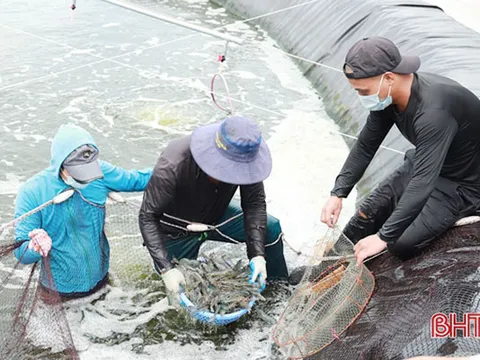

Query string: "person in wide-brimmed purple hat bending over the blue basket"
[139, 116, 288, 295]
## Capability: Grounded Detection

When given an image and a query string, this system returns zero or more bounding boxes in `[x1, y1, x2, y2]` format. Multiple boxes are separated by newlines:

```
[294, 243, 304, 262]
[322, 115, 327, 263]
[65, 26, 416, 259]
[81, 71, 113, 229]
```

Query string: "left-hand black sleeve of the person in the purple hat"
[139, 157, 176, 272]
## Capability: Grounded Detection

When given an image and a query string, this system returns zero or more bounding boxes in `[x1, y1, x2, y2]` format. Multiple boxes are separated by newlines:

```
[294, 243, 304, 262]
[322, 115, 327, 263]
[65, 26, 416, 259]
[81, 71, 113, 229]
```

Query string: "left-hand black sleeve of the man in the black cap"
[331, 110, 393, 198]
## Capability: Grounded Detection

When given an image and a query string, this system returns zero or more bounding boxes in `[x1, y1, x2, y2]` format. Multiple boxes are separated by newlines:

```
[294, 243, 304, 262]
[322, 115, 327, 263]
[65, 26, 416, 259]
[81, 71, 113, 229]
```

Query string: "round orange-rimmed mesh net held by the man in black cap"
[273, 229, 374, 359]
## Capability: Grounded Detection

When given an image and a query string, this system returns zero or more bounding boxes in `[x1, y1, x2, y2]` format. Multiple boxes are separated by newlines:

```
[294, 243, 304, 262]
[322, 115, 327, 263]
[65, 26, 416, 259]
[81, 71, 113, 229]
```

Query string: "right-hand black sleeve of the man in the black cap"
[378, 110, 458, 243]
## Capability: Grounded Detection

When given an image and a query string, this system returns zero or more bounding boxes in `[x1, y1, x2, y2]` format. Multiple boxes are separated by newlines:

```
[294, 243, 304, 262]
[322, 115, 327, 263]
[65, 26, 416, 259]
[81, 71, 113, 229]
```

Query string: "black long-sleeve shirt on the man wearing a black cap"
[332, 73, 480, 243]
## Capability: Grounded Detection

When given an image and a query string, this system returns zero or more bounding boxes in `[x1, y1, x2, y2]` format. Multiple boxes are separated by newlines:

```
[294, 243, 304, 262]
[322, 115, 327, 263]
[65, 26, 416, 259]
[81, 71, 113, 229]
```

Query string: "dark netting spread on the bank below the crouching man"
[310, 223, 480, 360]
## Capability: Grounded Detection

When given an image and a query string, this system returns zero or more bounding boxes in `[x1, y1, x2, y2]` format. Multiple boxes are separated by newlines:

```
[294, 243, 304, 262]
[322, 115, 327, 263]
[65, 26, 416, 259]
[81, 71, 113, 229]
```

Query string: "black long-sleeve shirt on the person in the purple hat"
[139, 136, 267, 272]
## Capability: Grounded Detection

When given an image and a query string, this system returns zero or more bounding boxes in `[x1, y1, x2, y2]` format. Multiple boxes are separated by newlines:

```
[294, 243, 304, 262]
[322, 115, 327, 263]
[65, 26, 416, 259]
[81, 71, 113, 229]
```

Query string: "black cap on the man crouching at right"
[343, 36, 420, 79]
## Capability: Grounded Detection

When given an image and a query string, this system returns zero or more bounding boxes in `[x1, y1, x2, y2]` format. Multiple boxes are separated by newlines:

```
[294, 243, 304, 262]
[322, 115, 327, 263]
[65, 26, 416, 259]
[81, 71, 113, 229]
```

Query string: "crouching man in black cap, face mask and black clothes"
[321, 37, 480, 264]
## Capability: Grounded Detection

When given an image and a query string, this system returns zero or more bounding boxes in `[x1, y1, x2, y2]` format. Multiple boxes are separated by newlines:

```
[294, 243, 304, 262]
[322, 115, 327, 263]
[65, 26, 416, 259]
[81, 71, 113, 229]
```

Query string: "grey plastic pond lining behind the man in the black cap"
[215, 0, 480, 204]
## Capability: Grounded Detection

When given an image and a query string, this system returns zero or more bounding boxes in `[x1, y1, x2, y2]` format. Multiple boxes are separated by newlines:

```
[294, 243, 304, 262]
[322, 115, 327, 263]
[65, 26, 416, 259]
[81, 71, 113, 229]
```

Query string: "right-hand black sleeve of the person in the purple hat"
[240, 182, 267, 259]
